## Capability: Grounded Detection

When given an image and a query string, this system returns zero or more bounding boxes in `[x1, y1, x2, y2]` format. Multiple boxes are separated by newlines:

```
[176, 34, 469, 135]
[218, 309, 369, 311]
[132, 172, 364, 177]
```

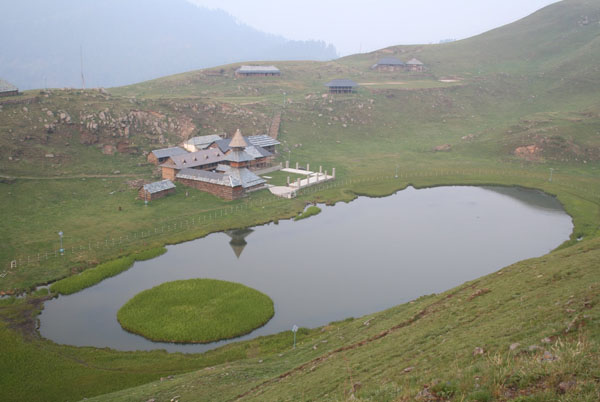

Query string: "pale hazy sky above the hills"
[189, 0, 557, 56]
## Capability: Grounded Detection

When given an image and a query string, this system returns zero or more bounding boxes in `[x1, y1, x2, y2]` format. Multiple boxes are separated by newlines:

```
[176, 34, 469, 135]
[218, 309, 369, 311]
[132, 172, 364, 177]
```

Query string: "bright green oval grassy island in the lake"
[117, 279, 275, 343]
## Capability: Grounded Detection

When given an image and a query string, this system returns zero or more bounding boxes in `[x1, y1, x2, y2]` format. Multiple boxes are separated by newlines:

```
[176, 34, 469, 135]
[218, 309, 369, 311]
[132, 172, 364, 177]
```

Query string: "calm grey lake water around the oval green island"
[40, 187, 573, 353]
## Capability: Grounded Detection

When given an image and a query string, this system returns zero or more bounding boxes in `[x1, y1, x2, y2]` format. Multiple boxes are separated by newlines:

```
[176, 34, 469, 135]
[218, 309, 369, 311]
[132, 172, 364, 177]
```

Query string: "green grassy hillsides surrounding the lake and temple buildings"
[0, 0, 600, 401]
